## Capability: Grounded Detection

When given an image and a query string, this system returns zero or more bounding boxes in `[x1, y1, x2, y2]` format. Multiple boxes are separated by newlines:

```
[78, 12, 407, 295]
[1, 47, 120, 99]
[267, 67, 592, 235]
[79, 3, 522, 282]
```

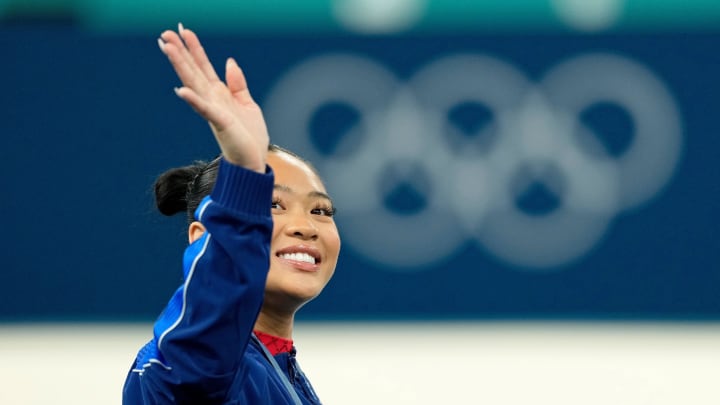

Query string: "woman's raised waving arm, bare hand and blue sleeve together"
[123, 27, 273, 405]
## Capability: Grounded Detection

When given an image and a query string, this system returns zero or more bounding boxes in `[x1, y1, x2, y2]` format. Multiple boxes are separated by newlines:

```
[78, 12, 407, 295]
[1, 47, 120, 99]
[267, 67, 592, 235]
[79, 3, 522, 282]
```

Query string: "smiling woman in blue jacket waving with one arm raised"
[123, 25, 340, 404]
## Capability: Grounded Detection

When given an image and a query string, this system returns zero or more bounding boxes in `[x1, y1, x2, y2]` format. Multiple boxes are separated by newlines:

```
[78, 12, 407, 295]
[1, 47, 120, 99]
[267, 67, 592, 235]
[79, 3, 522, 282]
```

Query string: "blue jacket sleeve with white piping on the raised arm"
[123, 160, 273, 405]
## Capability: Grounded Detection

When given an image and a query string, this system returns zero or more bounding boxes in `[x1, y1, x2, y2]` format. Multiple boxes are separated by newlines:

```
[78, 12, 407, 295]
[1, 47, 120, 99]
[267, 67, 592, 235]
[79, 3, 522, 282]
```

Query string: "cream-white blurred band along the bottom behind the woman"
[0, 322, 720, 405]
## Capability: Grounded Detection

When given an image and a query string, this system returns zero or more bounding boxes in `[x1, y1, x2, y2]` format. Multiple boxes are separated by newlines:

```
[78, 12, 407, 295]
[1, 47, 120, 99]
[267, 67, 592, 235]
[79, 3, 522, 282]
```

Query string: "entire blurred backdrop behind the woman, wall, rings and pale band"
[0, 0, 720, 404]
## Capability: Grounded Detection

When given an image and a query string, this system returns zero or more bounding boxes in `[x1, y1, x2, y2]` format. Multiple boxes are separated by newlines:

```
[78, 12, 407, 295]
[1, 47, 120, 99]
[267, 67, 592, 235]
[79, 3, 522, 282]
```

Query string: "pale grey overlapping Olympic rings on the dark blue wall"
[263, 53, 682, 271]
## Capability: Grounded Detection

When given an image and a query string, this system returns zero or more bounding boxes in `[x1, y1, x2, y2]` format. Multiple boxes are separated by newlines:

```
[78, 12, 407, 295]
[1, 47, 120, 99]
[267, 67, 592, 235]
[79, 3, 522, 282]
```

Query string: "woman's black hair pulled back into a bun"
[155, 144, 317, 223]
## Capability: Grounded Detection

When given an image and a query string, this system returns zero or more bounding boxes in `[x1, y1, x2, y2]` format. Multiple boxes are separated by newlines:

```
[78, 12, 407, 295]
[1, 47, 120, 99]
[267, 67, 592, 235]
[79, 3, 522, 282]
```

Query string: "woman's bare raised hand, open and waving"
[158, 24, 270, 173]
